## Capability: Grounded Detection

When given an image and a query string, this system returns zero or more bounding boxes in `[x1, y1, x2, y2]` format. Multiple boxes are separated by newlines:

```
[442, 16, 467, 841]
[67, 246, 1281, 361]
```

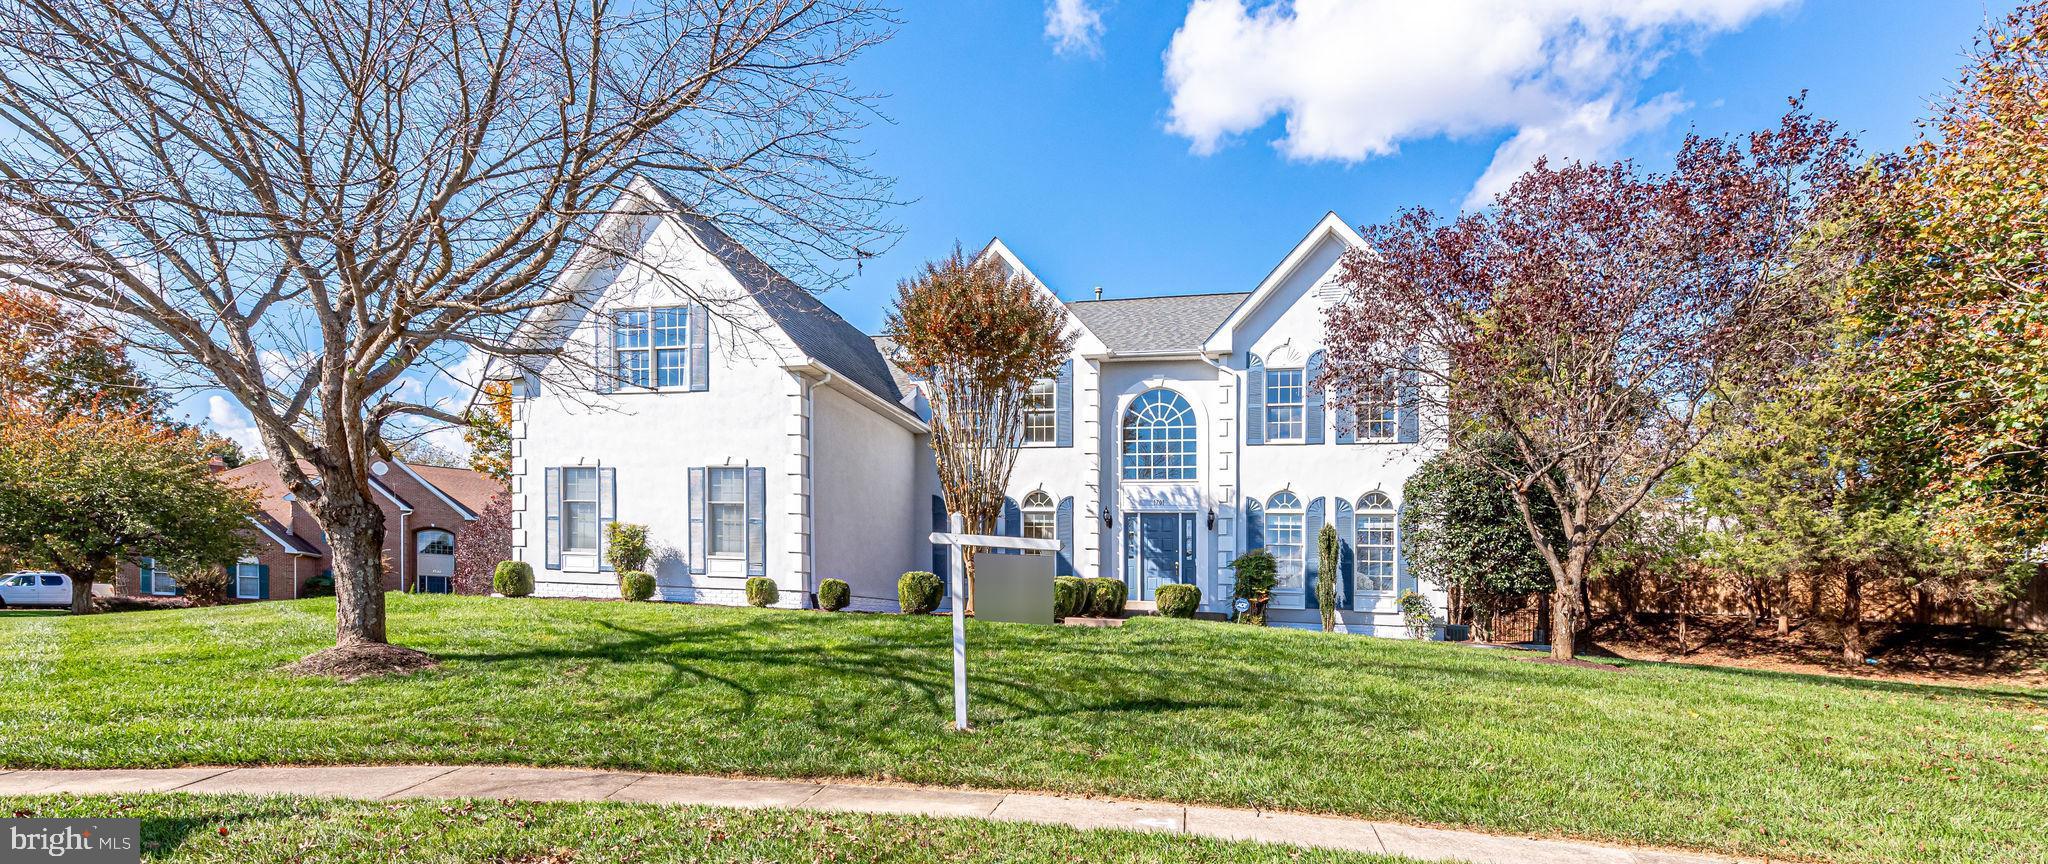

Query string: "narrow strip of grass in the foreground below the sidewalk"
[0, 794, 1407, 864]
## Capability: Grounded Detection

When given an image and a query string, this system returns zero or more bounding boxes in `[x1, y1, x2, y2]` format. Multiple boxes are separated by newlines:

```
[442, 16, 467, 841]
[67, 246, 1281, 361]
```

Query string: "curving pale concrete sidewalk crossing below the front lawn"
[0, 766, 1733, 864]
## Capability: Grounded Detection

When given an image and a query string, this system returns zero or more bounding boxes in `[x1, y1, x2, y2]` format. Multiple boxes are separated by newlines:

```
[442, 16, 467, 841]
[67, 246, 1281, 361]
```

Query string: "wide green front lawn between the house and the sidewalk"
[0, 596, 2048, 864]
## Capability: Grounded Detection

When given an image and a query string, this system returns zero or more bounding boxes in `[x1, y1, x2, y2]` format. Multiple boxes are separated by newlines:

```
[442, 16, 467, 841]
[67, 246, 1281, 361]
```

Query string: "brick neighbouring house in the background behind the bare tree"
[115, 459, 508, 600]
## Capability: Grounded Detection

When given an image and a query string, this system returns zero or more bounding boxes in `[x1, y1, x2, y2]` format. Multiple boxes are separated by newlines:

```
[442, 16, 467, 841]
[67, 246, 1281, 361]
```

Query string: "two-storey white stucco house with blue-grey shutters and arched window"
[498, 180, 1444, 637]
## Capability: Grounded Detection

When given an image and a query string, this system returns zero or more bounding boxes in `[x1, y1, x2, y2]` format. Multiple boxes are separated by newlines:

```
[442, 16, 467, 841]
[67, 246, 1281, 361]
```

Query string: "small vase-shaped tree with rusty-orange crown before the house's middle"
[887, 246, 1073, 610]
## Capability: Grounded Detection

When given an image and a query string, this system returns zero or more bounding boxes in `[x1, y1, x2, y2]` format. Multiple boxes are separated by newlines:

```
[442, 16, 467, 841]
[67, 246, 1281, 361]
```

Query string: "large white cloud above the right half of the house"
[1165, 0, 1796, 203]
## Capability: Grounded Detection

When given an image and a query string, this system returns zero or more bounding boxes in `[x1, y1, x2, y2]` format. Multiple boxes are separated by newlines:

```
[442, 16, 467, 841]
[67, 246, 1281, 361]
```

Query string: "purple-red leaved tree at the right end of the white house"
[1325, 108, 1855, 659]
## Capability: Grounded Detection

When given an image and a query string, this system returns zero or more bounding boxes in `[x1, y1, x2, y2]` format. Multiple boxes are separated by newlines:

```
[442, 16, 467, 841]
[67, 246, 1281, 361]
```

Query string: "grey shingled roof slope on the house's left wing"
[637, 180, 909, 414]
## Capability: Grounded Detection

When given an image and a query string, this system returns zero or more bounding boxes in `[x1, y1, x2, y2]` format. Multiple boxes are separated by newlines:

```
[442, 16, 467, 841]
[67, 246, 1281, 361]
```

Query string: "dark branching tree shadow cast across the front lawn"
[436, 618, 1245, 729]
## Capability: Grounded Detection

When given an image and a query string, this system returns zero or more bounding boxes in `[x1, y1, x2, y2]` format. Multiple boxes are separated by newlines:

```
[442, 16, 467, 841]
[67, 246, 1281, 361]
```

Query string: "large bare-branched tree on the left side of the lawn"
[0, 0, 893, 663]
